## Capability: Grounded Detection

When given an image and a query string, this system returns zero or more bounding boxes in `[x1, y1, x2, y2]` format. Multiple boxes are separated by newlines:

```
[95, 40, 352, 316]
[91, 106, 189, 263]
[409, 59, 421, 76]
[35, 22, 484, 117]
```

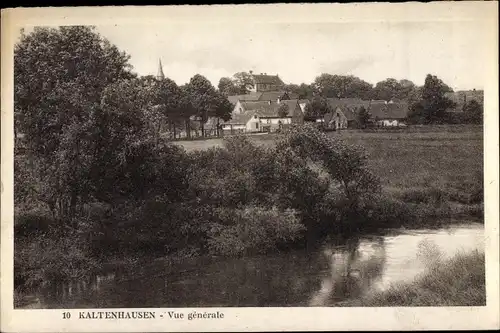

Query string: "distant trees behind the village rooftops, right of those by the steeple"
[218, 72, 483, 124]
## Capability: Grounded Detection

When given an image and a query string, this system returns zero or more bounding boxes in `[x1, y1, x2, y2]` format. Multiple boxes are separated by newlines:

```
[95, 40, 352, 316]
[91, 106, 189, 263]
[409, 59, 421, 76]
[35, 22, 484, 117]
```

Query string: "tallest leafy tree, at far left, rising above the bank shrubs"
[14, 26, 134, 220]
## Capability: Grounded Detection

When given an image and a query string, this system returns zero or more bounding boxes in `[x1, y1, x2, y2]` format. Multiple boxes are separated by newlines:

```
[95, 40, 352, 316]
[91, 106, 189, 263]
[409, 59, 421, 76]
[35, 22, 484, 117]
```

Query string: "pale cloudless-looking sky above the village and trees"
[93, 21, 488, 90]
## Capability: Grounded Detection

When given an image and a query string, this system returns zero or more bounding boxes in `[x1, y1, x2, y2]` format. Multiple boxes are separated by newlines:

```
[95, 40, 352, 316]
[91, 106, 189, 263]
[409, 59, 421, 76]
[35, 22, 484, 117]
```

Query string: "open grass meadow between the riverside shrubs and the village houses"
[178, 125, 483, 217]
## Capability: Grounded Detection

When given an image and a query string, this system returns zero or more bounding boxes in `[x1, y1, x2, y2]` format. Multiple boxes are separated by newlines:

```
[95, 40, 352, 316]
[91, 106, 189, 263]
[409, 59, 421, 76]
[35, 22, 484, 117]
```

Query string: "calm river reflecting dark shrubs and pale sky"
[21, 223, 484, 308]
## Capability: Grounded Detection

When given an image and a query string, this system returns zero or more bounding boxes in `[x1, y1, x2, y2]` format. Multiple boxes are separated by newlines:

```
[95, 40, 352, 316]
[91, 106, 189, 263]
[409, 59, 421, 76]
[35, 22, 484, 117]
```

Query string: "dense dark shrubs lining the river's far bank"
[15, 126, 482, 294]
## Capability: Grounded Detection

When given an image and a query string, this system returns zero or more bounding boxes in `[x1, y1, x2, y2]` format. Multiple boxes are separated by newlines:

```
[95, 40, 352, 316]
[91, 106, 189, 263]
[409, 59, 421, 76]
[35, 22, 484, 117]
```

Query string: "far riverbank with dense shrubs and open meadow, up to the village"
[15, 127, 483, 298]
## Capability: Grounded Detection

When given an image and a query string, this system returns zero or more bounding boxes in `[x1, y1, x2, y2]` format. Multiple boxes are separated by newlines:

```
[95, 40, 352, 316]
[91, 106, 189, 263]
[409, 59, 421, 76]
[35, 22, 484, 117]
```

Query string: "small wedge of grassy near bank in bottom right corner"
[338, 250, 486, 307]
